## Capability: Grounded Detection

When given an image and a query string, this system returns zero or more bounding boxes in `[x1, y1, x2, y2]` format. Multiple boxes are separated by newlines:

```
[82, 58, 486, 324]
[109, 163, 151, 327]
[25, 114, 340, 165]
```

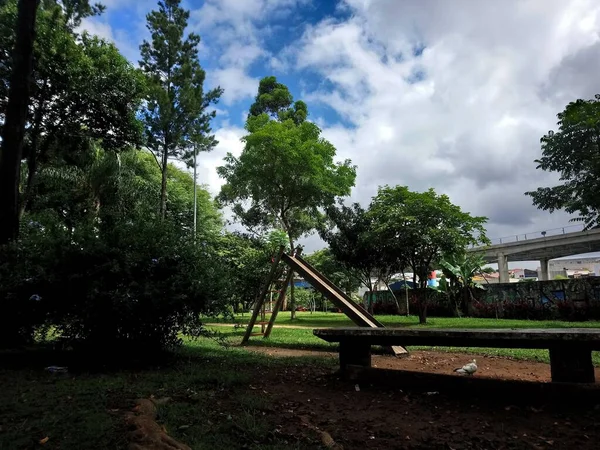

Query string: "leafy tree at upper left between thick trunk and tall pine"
[0, 0, 143, 239]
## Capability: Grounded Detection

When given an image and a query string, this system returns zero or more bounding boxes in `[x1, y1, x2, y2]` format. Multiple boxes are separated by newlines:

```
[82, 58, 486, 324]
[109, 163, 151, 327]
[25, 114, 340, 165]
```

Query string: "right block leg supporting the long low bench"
[550, 346, 595, 383]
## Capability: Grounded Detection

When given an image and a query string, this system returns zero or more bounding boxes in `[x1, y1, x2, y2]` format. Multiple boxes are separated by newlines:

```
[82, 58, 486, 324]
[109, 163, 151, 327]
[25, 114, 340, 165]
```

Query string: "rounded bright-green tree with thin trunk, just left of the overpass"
[369, 186, 488, 323]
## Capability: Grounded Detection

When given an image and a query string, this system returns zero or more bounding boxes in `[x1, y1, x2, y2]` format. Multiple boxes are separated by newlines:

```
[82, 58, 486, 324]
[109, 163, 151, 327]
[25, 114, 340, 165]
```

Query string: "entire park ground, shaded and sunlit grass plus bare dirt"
[0, 312, 600, 450]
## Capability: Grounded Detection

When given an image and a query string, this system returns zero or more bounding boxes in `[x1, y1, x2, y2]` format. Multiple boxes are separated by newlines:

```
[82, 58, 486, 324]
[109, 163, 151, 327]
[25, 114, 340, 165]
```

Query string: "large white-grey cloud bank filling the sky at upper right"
[296, 0, 600, 255]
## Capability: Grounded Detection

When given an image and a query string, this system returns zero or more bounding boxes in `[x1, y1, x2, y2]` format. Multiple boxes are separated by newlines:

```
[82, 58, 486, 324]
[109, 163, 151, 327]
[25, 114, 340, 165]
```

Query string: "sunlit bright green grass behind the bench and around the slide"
[205, 311, 600, 366]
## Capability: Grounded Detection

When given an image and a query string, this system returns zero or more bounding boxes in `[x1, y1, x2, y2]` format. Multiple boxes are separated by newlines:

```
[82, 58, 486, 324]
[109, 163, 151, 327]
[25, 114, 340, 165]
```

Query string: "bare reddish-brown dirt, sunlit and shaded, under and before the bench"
[249, 347, 600, 450]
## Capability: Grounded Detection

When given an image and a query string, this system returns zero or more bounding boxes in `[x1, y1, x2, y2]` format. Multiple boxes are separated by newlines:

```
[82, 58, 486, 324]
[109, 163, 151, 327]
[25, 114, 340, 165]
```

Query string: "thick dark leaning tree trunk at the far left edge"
[0, 0, 39, 245]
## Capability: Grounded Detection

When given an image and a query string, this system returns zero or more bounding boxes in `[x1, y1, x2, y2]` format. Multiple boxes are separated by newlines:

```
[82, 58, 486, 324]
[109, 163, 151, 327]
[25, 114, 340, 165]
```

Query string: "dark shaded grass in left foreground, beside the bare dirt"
[0, 338, 334, 450]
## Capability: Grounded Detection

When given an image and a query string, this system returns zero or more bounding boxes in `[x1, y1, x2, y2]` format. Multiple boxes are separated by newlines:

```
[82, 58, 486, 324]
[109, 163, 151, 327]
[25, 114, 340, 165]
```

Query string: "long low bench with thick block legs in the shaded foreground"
[313, 327, 600, 383]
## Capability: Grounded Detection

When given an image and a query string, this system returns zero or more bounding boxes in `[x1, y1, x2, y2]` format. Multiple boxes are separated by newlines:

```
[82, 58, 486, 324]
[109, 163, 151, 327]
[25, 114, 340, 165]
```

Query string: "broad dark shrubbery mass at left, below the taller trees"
[0, 146, 228, 351]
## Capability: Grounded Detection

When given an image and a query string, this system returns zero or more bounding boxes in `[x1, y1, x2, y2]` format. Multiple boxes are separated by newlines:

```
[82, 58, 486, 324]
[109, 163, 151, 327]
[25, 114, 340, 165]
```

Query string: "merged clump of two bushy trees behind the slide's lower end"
[320, 186, 487, 322]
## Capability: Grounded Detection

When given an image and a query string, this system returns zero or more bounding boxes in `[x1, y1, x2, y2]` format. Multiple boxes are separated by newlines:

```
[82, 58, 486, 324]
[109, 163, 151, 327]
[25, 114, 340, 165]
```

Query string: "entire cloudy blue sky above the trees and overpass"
[82, 0, 600, 267]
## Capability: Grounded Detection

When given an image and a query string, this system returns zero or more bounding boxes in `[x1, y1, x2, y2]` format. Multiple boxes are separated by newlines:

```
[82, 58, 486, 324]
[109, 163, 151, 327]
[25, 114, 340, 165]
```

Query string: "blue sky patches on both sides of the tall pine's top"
[84, 0, 351, 128]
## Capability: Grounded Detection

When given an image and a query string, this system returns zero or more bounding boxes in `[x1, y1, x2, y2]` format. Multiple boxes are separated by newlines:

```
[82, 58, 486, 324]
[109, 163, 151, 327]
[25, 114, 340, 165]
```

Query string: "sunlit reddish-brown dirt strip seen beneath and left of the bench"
[246, 346, 600, 384]
